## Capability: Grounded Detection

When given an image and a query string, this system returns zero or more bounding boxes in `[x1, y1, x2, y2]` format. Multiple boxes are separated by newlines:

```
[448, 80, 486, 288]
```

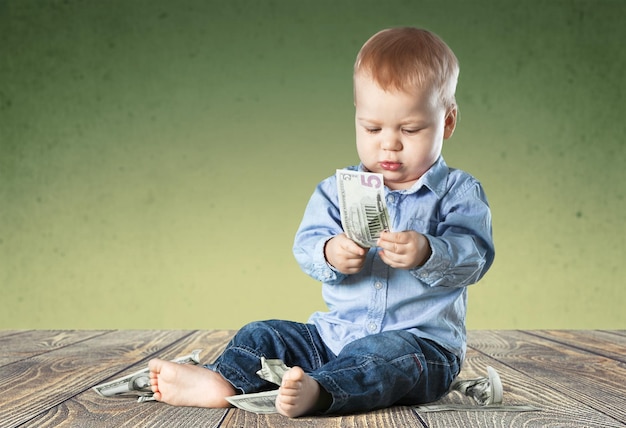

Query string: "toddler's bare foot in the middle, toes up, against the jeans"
[276, 366, 320, 418]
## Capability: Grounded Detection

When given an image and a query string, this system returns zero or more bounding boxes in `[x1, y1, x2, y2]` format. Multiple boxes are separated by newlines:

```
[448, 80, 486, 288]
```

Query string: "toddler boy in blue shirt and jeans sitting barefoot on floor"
[149, 28, 494, 417]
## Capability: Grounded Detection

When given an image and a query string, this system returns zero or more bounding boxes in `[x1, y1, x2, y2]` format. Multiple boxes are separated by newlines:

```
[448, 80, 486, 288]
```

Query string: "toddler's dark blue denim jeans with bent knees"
[205, 320, 460, 414]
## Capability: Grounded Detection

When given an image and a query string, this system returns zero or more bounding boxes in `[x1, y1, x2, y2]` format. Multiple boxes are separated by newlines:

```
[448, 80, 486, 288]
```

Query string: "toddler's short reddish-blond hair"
[354, 27, 459, 109]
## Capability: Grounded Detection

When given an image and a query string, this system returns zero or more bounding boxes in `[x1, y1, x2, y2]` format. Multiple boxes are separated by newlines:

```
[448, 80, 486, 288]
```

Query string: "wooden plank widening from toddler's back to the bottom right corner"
[469, 330, 626, 426]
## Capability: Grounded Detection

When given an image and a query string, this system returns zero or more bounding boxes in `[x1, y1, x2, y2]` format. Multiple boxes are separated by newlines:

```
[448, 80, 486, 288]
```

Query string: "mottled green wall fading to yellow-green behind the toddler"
[0, 0, 626, 329]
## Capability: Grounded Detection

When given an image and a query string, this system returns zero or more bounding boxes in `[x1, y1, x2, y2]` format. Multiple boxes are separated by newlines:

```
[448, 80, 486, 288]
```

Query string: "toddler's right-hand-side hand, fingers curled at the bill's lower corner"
[377, 230, 432, 269]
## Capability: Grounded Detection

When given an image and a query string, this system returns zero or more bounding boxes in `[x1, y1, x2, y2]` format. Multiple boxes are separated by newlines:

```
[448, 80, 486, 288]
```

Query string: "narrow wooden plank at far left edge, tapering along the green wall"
[0, 330, 106, 366]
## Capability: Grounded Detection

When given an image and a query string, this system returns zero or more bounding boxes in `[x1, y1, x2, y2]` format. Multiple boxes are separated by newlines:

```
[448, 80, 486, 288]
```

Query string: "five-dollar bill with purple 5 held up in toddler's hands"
[336, 169, 391, 248]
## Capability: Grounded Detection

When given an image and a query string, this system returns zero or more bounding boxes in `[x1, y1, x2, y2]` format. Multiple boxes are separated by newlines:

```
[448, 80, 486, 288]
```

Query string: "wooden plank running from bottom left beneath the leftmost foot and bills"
[24, 331, 234, 428]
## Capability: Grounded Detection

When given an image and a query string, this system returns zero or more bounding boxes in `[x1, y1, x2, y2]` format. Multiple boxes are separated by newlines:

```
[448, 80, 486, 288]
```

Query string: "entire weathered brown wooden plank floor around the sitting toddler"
[0, 330, 626, 428]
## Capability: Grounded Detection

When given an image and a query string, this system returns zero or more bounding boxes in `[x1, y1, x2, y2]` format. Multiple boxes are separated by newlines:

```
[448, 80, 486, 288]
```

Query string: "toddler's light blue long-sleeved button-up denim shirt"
[293, 157, 494, 360]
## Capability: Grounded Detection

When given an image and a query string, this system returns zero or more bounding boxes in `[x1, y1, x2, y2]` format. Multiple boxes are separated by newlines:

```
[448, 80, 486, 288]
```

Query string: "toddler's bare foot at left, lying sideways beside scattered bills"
[148, 359, 236, 407]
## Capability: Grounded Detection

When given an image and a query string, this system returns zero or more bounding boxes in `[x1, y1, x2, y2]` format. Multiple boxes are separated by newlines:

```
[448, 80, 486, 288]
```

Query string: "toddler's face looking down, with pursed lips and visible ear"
[354, 76, 456, 190]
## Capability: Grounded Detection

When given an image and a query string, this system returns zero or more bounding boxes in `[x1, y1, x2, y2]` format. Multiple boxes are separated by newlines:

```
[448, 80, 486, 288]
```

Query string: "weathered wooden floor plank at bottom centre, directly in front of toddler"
[220, 406, 425, 428]
